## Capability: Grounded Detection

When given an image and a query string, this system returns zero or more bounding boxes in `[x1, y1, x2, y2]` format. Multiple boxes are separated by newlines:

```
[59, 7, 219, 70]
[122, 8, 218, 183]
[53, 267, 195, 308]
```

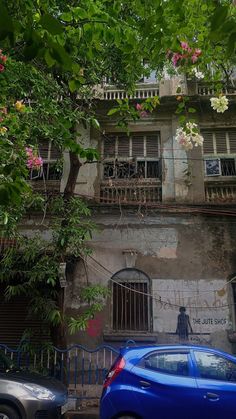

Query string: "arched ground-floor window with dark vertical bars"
[112, 268, 150, 331]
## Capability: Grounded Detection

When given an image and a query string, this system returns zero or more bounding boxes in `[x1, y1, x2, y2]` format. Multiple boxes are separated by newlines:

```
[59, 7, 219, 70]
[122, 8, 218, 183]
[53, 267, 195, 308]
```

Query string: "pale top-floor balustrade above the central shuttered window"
[99, 83, 159, 100]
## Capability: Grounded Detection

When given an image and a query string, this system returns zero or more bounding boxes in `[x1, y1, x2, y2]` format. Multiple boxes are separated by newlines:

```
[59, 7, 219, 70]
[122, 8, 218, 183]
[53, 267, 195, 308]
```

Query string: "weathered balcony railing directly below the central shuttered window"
[100, 181, 162, 205]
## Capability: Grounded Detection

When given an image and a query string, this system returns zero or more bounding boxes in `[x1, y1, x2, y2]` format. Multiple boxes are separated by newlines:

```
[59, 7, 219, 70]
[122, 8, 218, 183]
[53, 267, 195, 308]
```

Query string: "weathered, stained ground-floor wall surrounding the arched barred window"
[64, 210, 236, 350]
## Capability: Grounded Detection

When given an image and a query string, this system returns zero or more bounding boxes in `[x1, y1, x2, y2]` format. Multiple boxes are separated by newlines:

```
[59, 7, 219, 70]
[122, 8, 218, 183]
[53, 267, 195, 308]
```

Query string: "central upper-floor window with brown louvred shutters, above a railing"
[103, 132, 161, 180]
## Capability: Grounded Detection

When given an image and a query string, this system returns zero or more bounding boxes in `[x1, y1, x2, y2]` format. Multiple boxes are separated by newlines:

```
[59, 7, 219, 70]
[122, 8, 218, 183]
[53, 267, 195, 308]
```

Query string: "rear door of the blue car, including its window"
[129, 349, 201, 419]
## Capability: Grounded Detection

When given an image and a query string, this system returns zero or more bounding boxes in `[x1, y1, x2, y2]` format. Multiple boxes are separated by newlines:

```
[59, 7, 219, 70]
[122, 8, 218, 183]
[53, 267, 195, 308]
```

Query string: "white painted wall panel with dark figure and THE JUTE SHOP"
[152, 279, 230, 341]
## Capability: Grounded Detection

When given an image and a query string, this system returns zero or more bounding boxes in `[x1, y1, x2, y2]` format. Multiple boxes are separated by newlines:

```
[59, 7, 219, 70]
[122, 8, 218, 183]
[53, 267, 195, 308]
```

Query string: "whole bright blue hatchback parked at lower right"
[100, 345, 236, 419]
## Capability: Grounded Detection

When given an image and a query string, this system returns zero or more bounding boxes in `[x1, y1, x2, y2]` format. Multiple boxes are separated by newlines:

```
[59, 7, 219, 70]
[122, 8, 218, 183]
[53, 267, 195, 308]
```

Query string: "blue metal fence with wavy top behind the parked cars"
[0, 341, 135, 399]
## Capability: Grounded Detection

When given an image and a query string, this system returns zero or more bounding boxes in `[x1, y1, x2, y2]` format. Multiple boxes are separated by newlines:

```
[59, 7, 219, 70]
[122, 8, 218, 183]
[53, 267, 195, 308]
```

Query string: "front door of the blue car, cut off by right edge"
[193, 349, 236, 419]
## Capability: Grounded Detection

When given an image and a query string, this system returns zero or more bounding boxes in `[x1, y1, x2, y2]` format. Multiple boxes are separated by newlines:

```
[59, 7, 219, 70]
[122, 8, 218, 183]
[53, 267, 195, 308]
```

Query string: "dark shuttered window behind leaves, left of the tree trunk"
[30, 141, 62, 180]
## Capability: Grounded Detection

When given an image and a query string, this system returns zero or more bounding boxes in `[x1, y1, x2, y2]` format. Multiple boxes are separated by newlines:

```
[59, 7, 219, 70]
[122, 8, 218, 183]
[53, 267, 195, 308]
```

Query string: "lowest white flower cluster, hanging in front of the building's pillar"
[175, 122, 204, 151]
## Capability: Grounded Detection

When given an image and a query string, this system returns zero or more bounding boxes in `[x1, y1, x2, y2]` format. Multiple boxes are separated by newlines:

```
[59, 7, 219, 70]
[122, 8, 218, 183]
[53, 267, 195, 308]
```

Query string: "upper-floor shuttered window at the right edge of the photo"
[203, 130, 236, 176]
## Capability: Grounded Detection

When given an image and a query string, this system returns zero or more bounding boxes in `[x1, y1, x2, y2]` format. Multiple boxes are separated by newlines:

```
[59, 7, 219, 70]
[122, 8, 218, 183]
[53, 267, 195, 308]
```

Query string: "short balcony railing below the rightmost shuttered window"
[205, 182, 236, 203]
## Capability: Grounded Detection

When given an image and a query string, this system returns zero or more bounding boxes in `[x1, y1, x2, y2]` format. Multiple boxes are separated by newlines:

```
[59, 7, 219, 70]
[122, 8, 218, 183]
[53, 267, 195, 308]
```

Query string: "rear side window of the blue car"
[143, 352, 189, 376]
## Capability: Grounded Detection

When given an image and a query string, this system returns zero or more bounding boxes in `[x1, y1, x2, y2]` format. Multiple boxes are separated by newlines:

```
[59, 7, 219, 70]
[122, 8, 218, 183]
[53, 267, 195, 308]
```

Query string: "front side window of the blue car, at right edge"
[194, 351, 236, 382]
